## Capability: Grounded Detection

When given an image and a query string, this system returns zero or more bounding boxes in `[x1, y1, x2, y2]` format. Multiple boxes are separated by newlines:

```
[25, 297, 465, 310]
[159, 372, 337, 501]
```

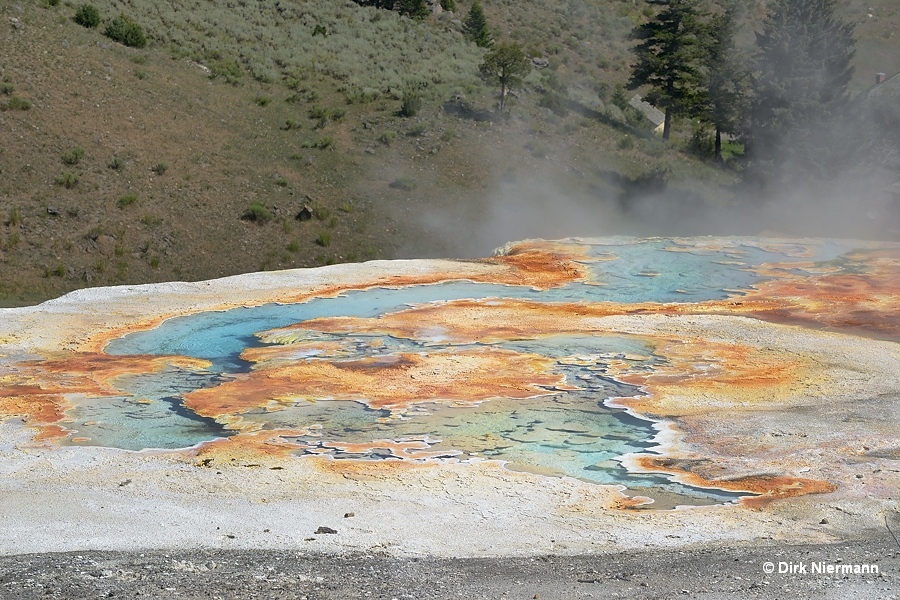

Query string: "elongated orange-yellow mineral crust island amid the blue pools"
[185, 348, 565, 421]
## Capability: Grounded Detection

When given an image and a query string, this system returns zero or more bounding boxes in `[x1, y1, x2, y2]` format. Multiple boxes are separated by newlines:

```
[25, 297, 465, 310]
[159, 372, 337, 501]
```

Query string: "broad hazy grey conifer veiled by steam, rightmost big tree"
[747, 0, 854, 185]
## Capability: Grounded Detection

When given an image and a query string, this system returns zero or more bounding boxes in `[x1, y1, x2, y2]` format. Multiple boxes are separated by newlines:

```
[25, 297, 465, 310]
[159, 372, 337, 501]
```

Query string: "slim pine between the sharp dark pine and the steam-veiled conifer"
[702, 0, 750, 162]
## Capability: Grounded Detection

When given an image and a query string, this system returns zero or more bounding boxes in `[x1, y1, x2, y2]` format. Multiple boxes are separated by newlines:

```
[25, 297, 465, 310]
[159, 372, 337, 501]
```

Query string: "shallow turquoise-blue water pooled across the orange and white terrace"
[82, 238, 846, 503]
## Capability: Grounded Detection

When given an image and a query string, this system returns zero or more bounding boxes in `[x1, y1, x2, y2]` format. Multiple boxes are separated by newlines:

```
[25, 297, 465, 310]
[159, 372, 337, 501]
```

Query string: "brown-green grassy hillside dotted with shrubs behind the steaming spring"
[0, 0, 900, 305]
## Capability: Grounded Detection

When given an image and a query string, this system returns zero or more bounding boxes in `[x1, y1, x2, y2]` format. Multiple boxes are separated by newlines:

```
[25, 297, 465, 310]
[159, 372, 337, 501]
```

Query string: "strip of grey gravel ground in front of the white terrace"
[0, 532, 900, 600]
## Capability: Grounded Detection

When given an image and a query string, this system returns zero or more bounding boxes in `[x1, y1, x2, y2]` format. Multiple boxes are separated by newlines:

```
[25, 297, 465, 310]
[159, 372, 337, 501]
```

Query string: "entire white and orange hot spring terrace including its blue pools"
[0, 237, 900, 556]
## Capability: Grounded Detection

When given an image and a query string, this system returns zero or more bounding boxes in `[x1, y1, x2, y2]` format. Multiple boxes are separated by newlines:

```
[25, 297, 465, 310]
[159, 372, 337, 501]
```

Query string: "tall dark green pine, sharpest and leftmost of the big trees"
[627, 0, 705, 139]
